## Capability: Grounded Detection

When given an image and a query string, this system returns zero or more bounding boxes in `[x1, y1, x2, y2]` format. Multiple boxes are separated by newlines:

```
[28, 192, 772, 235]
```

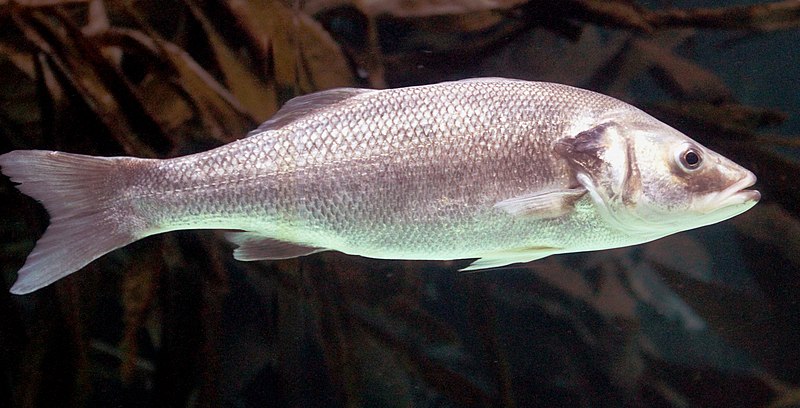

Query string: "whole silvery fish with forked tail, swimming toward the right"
[0, 78, 760, 294]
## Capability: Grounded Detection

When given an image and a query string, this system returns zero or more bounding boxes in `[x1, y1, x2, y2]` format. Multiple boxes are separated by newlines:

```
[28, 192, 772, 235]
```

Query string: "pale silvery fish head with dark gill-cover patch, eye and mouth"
[556, 111, 760, 239]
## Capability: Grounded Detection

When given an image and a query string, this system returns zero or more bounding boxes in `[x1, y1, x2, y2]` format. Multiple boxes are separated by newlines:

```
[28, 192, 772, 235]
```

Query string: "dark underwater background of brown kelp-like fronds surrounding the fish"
[0, 0, 800, 407]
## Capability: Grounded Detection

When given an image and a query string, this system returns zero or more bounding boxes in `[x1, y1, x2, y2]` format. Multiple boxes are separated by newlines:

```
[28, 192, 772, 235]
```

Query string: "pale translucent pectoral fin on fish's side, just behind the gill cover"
[494, 187, 586, 219]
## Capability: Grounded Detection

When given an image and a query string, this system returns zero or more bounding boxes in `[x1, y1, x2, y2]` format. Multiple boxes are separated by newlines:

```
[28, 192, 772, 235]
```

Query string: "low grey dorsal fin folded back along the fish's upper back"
[247, 88, 379, 137]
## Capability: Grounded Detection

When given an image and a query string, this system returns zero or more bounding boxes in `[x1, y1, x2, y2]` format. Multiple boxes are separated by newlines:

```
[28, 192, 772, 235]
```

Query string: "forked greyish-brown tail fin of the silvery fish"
[0, 150, 140, 294]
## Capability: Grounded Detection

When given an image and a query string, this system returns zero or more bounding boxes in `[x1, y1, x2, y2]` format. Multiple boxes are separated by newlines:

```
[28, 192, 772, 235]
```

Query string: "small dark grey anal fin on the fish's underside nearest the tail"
[225, 231, 325, 261]
